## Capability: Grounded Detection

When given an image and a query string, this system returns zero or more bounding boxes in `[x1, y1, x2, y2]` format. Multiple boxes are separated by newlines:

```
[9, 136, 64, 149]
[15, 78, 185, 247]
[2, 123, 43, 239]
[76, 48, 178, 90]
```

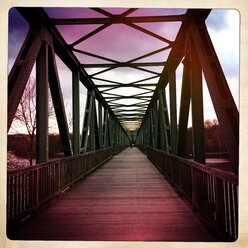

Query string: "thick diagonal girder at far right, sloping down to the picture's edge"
[192, 19, 239, 168]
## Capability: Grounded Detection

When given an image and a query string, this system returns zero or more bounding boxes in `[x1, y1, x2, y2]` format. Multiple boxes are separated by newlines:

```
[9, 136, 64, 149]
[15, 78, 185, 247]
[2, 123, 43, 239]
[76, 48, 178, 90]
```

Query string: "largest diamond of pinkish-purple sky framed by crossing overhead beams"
[73, 24, 168, 62]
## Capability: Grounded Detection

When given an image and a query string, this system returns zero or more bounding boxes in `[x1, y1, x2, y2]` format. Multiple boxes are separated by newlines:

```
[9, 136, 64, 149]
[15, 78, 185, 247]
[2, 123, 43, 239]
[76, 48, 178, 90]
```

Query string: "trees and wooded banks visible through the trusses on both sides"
[8, 78, 226, 169]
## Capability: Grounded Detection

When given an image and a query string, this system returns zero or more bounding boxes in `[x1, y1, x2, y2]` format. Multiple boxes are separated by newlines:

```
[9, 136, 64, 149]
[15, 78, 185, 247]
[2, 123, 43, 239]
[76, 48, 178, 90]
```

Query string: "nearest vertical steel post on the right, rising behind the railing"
[191, 42, 205, 164]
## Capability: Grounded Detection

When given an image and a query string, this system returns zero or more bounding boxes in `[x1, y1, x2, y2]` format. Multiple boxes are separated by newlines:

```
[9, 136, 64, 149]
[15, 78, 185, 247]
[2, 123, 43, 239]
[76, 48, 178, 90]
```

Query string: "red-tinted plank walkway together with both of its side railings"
[8, 147, 238, 241]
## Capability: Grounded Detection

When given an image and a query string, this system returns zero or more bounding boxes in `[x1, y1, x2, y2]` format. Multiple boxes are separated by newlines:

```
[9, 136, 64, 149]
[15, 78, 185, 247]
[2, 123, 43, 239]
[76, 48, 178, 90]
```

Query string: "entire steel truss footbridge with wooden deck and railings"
[7, 8, 239, 241]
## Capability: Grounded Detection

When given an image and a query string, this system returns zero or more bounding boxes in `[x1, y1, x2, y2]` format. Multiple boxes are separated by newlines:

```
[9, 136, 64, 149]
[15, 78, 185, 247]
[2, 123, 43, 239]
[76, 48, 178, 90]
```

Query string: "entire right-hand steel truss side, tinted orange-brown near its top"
[137, 10, 239, 172]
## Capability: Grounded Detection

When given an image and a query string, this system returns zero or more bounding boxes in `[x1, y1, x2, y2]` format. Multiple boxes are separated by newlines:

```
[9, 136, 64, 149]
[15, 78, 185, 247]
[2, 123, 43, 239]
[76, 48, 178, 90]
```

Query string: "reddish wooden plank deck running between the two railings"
[11, 148, 215, 241]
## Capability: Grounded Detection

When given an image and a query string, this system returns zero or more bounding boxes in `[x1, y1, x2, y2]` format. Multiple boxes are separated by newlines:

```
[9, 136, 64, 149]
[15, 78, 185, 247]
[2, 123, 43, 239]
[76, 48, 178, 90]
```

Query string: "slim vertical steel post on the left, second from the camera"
[72, 71, 80, 155]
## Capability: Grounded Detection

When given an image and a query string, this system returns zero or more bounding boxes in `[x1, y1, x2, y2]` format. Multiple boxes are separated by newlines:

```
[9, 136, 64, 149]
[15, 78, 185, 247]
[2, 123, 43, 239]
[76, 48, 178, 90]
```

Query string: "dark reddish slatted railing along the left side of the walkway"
[7, 148, 112, 229]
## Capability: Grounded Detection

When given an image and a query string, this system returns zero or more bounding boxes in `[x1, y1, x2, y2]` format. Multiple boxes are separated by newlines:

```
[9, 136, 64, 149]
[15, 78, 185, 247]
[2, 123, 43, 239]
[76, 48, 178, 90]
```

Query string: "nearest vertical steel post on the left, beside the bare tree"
[36, 42, 48, 163]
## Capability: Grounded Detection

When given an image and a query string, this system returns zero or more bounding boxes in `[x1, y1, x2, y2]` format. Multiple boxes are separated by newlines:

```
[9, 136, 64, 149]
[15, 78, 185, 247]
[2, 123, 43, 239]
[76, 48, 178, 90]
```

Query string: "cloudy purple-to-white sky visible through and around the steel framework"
[8, 8, 240, 134]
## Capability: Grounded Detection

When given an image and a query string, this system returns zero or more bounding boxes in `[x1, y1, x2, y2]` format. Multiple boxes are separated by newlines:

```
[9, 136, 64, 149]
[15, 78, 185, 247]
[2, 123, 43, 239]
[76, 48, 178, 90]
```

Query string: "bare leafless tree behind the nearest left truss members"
[11, 78, 54, 166]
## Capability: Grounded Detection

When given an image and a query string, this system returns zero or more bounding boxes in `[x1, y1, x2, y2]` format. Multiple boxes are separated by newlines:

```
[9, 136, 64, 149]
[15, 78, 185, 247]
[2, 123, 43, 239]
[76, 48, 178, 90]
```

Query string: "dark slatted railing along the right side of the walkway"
[143, 147, 238, 241]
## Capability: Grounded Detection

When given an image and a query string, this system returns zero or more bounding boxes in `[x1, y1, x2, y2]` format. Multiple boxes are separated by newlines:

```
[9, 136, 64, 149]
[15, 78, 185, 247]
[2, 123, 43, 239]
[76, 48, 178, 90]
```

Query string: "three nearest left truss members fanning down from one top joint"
[8, 24, 71, 163]
